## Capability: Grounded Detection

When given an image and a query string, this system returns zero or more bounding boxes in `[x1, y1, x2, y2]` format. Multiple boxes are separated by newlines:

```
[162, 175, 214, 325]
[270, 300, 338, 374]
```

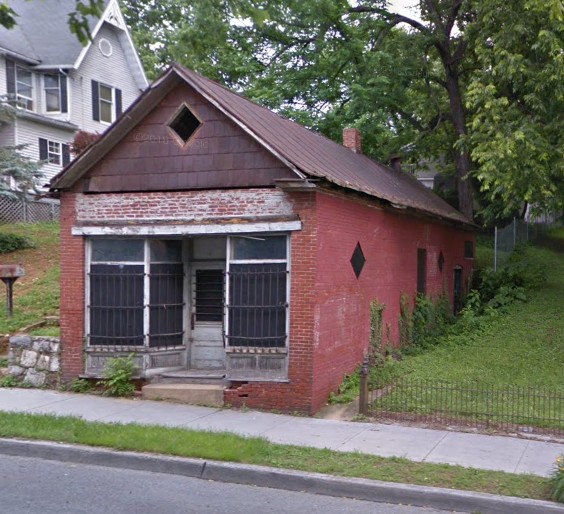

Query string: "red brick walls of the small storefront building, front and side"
[61, 188, 473, 414]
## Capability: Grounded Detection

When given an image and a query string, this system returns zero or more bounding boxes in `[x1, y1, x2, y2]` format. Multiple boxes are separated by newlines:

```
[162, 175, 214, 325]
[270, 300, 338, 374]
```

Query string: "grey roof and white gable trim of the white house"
[0, 0, 148, 89]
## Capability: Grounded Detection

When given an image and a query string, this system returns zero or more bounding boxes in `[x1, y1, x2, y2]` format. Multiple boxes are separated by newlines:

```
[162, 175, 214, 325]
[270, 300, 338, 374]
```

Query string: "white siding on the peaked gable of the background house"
[69, 23, 140, 133]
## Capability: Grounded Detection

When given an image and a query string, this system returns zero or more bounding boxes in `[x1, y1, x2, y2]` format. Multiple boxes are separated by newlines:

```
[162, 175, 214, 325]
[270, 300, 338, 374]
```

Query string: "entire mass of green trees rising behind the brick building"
[124, 0, 562, 222]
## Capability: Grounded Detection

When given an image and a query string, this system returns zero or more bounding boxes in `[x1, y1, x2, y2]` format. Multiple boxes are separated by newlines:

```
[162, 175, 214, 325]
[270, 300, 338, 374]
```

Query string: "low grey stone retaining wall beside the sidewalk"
[8, 335, 61, 387]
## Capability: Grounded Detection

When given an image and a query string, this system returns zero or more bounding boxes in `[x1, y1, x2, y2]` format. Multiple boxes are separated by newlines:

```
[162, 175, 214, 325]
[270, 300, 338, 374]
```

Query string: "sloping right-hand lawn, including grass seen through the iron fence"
[371, 230, 564, 426]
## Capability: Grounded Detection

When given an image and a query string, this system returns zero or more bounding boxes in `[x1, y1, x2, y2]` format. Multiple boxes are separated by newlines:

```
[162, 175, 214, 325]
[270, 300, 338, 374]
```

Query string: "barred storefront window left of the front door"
[88, 239, 184, 347]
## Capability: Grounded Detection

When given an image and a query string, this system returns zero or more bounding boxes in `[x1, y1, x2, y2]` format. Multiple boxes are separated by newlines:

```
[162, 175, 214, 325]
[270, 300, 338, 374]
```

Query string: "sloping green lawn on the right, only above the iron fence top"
[386, 234, 564, 384]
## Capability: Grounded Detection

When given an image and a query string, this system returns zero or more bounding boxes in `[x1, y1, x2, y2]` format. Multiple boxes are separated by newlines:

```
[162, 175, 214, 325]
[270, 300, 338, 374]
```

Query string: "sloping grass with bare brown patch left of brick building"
[0, 223, 60, 335]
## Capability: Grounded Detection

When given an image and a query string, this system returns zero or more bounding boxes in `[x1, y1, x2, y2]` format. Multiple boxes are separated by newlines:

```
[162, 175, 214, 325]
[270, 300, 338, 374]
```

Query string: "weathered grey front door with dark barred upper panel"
[190, 261, 225, 369]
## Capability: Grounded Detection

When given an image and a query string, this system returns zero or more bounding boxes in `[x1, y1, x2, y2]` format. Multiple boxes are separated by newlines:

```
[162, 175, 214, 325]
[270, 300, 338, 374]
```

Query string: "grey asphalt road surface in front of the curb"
[0, 455, 458, 514]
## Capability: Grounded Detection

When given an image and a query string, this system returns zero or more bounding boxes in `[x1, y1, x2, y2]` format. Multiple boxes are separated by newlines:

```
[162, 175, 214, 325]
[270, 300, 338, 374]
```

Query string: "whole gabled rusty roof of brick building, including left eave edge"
[51, 64, 471, 224]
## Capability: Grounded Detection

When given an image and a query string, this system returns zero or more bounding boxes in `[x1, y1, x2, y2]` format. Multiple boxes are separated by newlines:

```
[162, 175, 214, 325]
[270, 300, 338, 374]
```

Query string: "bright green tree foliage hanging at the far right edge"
[467, 0, 564, 218]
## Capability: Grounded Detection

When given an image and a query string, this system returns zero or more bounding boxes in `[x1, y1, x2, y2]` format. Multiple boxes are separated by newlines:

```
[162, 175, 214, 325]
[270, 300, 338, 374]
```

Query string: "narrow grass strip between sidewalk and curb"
[0, 412, 549, 500]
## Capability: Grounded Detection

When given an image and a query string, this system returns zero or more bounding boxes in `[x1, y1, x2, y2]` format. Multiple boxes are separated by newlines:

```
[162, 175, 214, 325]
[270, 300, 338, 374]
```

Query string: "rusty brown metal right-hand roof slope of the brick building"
[175, 66, 469, 223]
